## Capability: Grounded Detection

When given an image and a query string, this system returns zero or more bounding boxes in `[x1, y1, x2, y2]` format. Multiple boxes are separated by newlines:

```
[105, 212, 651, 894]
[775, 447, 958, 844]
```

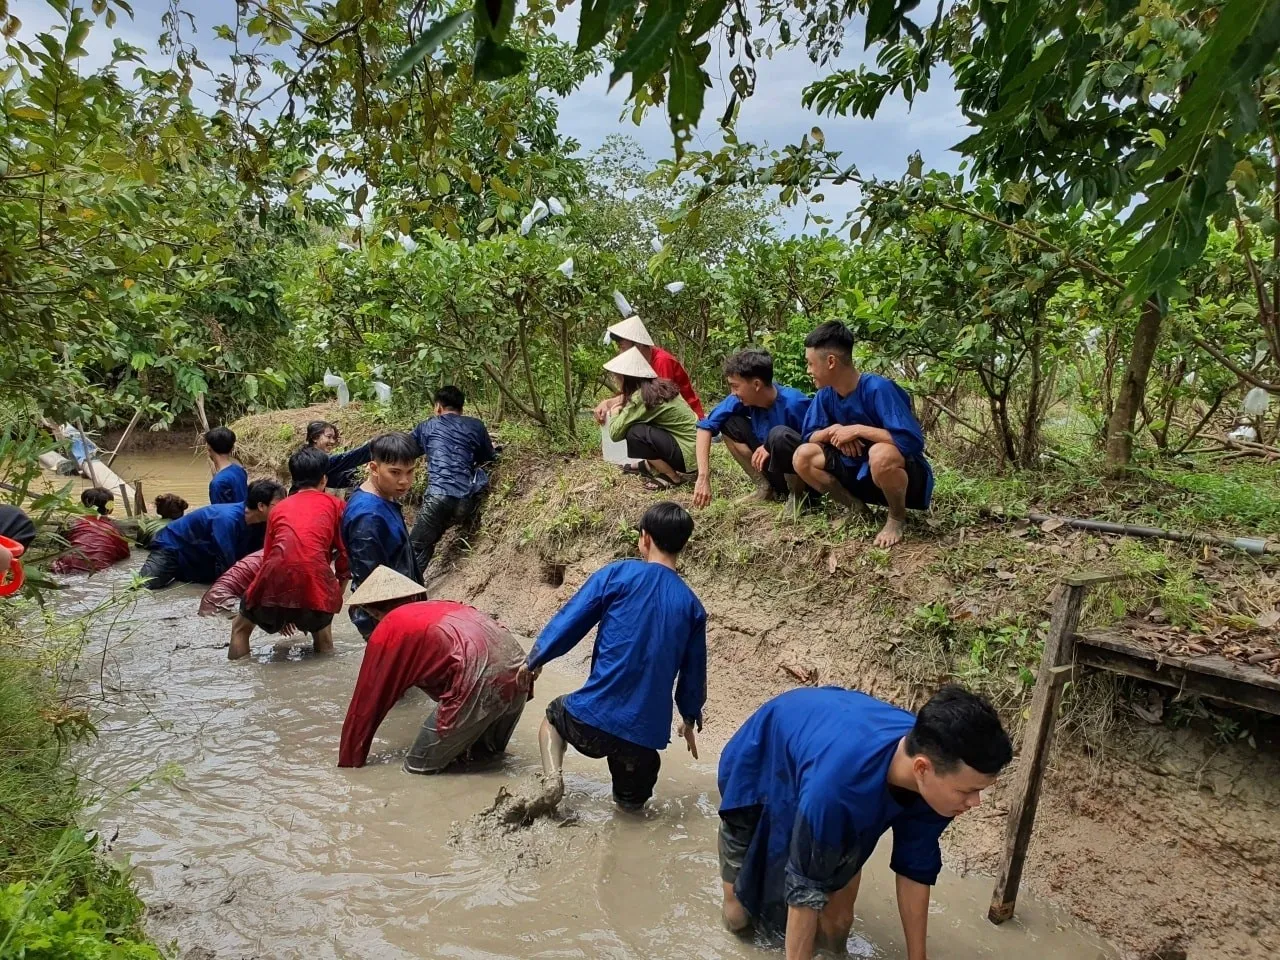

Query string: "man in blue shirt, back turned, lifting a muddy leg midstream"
[518, 502, 707, 812]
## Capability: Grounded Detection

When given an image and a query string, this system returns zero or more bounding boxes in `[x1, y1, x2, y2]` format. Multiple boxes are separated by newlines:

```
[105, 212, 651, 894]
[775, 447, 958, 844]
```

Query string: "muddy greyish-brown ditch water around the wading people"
[68, 568, 1115, 960]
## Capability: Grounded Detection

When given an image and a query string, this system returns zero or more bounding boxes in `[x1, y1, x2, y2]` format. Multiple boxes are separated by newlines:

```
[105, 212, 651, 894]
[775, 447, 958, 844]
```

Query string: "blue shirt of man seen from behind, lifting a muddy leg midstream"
[529, 559, 707, 750]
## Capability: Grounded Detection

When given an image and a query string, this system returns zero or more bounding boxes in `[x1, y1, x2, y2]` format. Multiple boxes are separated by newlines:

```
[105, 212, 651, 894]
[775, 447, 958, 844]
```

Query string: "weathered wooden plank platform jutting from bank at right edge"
[1075, 630, 1280, 717]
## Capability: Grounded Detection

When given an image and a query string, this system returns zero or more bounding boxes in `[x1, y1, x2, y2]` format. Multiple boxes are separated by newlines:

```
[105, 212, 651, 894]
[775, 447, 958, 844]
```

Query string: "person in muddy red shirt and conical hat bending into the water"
[338, 567, 529, 773]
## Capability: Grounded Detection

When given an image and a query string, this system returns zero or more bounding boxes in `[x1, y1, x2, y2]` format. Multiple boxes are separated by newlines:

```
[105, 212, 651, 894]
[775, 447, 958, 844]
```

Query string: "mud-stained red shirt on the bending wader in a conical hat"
[338, 600, 525, 767]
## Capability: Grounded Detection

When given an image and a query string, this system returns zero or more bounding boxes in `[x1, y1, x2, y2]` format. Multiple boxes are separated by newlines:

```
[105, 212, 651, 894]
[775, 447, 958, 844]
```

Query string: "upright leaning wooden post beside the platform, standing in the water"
[987, 584, 1088, 923]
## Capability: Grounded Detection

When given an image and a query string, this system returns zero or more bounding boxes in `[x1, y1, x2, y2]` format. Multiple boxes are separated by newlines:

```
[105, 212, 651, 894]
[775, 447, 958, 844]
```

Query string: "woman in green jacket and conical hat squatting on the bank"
[604, 347, 698, 490]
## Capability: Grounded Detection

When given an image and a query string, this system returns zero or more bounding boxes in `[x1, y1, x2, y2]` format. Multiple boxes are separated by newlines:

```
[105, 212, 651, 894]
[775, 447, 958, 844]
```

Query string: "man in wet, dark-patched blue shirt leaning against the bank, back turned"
[410, 387, 498, 577]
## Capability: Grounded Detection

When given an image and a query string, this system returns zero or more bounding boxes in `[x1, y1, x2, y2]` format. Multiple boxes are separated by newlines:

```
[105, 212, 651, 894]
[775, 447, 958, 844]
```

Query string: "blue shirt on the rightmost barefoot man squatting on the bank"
[800, 374, 933, 507]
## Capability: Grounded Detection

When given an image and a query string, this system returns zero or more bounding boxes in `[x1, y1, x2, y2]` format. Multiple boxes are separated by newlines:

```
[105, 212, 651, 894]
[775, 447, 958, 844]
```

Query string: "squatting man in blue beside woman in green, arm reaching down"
[694, 348, 809, 507]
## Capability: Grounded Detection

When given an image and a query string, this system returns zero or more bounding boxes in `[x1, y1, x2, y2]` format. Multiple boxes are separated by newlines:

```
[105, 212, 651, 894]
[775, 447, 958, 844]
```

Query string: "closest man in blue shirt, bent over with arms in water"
[718, 686, 1012, 960]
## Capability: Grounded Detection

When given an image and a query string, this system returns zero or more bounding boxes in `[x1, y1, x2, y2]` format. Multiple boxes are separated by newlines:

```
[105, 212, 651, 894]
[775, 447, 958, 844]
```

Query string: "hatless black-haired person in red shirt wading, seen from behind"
[227, 447, 351, 660]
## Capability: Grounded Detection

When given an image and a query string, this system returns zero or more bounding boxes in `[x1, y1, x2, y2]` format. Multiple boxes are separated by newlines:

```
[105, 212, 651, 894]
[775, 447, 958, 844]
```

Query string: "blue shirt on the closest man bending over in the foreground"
[719, 686, 951, 929]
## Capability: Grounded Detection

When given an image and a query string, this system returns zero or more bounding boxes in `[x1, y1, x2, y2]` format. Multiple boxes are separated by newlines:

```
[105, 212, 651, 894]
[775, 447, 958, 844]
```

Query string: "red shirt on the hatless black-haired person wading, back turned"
[244, 490, 351, 613]
